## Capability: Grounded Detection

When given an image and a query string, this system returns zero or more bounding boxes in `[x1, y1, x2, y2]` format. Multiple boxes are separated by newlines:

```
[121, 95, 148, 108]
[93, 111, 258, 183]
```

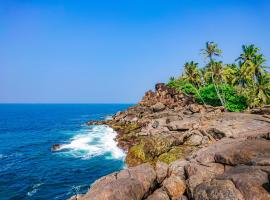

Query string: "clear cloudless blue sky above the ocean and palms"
[0, 0, 270, 103]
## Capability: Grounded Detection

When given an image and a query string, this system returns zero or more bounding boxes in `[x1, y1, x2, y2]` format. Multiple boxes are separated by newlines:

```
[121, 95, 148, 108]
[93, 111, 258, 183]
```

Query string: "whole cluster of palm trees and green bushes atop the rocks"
[168, 42, 270, 112]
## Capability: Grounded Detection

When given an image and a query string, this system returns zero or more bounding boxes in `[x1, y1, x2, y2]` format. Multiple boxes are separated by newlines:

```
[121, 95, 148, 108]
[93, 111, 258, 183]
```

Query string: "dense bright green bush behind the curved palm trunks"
[196, 84, 247, 112]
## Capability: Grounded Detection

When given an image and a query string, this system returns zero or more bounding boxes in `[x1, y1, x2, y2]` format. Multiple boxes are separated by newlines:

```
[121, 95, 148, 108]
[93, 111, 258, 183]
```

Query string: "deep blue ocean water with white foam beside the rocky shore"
[0, 104, 130, 200]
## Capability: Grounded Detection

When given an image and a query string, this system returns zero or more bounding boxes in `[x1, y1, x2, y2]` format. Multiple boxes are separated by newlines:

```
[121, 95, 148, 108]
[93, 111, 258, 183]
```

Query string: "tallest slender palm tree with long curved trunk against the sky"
[201, 42, 225, 107]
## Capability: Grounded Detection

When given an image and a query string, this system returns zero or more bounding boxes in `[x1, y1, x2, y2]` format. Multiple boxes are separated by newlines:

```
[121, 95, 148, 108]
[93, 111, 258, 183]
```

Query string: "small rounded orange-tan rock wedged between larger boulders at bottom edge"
[162, 176, 186, 198]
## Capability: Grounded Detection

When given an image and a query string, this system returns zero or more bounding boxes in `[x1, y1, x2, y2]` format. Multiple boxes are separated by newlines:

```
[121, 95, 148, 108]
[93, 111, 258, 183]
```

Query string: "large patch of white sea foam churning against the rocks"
[60, 125, 125, 159]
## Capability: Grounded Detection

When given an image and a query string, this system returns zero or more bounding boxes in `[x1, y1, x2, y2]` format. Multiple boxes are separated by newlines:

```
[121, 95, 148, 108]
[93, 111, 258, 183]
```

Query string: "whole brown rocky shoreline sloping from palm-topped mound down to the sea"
[72, 83, 270, 200]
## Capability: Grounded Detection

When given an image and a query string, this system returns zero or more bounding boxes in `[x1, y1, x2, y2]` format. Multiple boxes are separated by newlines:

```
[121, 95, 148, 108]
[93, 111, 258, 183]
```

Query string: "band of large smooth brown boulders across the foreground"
[76, 137, 270, 200]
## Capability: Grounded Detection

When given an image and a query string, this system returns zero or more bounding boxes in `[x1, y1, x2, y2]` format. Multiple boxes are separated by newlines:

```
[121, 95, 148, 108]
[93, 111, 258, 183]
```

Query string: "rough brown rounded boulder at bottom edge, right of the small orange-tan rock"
[194, 179, 245, 200]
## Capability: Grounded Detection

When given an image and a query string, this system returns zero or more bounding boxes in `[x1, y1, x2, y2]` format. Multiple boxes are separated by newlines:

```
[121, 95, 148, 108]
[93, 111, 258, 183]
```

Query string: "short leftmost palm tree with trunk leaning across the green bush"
[183, 61, 205, 104]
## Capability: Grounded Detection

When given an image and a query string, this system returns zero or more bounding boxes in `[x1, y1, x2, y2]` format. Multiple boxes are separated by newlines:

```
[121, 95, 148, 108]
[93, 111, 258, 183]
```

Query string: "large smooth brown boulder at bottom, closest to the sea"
[79, 164, 156, 200]
